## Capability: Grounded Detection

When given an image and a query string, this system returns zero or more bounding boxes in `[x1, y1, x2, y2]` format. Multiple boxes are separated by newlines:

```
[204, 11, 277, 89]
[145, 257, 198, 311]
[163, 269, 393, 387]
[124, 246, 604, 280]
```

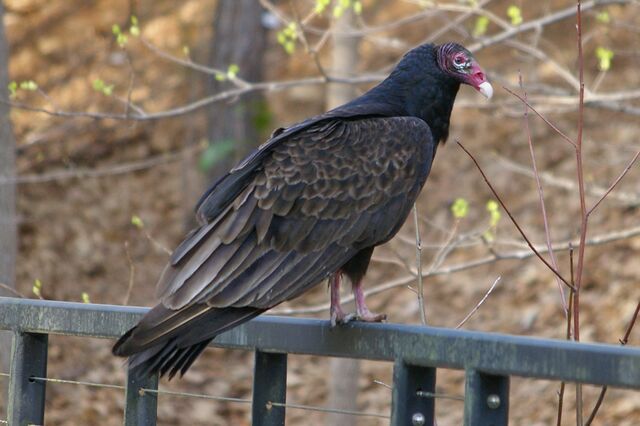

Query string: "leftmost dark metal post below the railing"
[7, 332, 49, 426]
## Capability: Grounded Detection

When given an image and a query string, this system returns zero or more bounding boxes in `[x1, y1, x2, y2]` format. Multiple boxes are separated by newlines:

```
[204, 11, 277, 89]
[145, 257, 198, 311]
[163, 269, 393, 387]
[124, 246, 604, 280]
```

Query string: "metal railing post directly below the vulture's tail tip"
[124, 370, 158, 426]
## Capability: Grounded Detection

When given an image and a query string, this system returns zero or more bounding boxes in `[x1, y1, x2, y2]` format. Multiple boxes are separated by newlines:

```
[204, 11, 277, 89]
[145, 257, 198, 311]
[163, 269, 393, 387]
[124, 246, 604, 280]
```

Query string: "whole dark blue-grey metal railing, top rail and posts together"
[0, 298, 640, 426]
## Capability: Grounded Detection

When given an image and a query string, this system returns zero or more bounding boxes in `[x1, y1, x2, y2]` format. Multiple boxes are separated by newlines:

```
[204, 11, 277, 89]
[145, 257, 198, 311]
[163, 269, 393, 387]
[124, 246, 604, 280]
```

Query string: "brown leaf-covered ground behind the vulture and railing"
[0, 0, 640, 426]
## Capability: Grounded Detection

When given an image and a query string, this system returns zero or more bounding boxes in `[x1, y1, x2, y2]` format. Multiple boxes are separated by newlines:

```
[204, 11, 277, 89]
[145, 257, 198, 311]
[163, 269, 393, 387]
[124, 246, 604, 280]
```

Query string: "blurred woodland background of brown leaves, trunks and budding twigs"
[0, 0, 640, 426]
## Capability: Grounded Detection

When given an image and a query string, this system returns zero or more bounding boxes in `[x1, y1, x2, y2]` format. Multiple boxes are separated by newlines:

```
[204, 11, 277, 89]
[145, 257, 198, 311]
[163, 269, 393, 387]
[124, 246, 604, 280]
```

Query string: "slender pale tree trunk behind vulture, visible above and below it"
[326, 10, 360, 426]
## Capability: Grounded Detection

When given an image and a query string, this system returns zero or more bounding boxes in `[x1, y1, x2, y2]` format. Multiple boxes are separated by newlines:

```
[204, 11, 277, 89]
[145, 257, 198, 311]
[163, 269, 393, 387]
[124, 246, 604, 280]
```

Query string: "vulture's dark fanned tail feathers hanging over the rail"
[112, 305, 265, 379]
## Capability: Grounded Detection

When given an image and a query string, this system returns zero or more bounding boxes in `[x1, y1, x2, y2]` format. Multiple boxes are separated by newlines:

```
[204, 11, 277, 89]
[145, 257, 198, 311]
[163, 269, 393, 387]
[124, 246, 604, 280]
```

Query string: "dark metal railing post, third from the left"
[251, 350, 287, 426]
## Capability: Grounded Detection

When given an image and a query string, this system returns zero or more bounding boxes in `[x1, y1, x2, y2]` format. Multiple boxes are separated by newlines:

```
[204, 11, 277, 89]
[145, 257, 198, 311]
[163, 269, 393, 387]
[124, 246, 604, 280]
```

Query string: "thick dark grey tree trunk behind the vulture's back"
[183, 0, 267, 228]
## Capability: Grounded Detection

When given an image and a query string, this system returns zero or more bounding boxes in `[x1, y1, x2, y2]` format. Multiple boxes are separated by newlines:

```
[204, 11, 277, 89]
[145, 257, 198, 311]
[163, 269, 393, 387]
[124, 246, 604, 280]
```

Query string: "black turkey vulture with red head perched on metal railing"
[113, 43, 493, 378]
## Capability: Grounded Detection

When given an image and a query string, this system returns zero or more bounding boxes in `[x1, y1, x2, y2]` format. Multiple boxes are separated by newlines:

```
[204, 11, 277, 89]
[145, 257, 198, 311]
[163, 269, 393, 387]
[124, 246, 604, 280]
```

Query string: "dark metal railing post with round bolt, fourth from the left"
[391, 359, 436, 426]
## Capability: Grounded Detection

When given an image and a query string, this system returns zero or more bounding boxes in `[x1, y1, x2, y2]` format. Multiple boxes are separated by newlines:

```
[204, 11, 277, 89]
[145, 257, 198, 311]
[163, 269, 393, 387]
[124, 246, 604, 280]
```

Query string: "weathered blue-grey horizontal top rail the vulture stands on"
[0, 297, 640, 389]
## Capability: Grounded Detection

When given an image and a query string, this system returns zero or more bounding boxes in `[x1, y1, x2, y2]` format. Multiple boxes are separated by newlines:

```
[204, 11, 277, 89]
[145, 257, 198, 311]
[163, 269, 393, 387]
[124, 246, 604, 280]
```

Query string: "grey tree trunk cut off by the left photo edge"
[0, 1, 17, 412]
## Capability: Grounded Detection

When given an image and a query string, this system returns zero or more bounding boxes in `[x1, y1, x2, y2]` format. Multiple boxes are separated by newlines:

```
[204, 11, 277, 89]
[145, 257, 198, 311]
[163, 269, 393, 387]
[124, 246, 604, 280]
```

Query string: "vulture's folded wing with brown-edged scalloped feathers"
[160, 117, 433, 309]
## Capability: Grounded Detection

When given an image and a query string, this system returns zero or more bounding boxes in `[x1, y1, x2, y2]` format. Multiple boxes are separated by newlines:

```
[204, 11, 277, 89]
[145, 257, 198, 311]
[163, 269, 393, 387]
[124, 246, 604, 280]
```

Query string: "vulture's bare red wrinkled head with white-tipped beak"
[435, 43, 493, 99]
